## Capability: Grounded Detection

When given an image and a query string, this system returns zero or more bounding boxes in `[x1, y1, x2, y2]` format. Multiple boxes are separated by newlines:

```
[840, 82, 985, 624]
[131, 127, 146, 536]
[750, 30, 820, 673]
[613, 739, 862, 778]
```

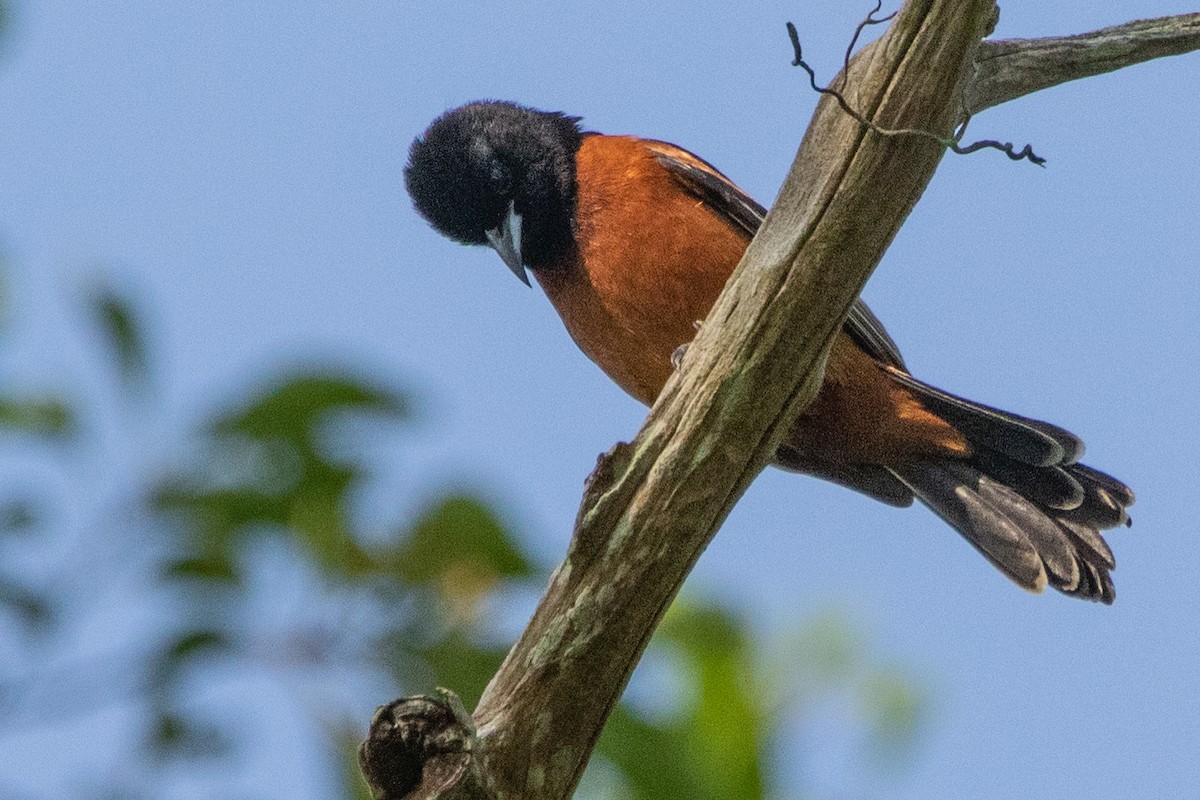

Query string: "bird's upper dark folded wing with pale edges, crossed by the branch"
[647, 140, 905, 369]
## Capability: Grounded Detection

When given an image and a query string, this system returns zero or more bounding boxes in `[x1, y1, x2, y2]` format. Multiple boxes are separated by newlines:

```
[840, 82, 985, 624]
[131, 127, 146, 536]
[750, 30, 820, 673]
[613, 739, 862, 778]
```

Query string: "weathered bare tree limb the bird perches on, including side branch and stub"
[362, 6, 1200, 800]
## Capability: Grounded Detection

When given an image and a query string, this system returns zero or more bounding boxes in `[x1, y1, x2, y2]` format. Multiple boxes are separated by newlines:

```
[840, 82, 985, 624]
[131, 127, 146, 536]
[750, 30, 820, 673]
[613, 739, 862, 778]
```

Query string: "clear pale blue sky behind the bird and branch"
[0, 0, 1200, 798]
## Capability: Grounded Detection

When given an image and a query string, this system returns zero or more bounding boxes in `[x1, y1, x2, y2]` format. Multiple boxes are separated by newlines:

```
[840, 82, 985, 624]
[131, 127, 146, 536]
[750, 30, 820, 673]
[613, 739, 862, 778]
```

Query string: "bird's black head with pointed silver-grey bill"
[404, 101, 582, 279]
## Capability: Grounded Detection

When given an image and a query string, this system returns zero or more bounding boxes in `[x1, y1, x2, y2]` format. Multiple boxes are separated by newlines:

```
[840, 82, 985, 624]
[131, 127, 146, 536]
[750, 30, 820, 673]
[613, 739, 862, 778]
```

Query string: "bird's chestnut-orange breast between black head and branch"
[535, 136, 748, 404]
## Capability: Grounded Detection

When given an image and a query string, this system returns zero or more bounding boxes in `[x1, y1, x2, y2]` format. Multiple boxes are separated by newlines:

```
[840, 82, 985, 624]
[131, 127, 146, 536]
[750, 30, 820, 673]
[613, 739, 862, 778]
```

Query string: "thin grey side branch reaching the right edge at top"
[966, 13, 1200, 114]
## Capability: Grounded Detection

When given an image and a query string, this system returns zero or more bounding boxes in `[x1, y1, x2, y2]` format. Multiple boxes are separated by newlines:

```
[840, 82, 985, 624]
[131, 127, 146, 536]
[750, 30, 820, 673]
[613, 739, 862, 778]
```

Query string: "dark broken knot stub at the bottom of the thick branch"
[359, 690, 492, 800]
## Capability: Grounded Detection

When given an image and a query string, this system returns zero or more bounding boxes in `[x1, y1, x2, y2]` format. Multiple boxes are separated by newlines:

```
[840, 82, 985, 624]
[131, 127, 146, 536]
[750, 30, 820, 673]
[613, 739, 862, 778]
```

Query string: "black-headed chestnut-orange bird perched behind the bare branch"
[404, 101, 1134, 604]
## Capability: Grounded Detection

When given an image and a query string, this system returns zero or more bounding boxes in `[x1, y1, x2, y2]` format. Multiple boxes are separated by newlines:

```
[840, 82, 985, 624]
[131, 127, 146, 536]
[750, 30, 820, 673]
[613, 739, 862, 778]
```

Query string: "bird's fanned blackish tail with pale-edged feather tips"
[889, 369, 1134, 603]
